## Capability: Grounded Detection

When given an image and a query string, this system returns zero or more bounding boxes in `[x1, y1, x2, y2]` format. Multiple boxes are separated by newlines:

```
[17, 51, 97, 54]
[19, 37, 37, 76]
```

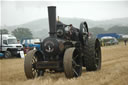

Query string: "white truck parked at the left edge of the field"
[0, 34, 23, 58]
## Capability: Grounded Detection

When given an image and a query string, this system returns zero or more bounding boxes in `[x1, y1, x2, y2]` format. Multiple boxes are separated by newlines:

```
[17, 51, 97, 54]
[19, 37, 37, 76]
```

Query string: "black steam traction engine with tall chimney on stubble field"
[24, 6, 101, 79]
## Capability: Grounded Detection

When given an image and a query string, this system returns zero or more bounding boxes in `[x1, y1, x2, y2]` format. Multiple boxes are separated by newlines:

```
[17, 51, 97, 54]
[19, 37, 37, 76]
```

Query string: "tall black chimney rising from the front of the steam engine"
[48, 6, 56, 37]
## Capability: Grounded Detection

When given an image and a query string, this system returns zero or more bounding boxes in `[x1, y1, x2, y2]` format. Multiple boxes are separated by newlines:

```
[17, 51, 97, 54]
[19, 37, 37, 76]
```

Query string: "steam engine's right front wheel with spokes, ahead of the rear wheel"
[64, 48, 82, 78]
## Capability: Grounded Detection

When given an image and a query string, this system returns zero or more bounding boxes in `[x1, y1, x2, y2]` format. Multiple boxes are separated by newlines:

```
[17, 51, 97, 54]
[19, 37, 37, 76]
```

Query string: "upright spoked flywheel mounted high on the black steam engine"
[79, 22, 89, 45]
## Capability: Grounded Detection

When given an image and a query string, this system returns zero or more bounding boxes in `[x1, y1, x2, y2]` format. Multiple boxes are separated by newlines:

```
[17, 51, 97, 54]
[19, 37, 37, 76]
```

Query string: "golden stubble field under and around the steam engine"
[0, 44, 128, 85]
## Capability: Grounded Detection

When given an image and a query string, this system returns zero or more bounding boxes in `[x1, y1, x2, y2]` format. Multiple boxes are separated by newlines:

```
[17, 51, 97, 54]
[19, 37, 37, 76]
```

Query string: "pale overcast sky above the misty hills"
[0, 0, 128, 26]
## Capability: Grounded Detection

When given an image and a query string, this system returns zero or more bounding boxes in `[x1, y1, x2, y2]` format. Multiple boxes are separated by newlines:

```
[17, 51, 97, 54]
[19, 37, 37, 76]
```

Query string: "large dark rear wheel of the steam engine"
[84, 39, 101, 71]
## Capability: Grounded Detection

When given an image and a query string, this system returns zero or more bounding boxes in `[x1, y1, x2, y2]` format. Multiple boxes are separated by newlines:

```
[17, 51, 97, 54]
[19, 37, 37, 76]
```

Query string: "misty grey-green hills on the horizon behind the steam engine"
[1, 17, 128, 38]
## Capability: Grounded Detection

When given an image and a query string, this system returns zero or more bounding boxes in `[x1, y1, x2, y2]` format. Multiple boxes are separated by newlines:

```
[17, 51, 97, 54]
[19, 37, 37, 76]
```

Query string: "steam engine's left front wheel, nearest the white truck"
[24, 50, 44, 79]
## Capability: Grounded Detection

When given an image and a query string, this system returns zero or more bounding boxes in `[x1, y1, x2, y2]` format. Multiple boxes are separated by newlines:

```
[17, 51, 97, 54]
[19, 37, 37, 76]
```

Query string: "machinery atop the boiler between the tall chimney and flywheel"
[56, 21, 79, 41]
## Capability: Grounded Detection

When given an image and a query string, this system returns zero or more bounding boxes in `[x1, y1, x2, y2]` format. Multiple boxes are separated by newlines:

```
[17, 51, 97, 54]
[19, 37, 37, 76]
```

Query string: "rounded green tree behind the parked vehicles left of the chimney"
[12, 28, 33, 40]
